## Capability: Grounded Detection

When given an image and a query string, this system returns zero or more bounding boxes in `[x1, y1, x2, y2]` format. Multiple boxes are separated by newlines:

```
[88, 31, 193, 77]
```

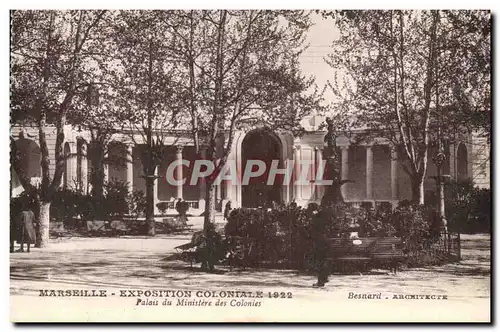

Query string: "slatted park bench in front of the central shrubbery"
[327, 237, 404, 274]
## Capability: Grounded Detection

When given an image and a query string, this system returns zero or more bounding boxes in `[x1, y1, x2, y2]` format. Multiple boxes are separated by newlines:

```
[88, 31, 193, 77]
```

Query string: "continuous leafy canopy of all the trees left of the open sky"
[11, 10, 321, 235]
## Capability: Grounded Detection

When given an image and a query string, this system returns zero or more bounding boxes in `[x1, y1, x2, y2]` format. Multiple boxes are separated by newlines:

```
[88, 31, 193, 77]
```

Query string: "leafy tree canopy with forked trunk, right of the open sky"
[324, 10, 491, 204]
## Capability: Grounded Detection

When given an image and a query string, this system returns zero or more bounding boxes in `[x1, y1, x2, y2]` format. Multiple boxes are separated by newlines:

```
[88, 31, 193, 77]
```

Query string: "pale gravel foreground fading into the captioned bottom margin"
[10, 234, 490, 321]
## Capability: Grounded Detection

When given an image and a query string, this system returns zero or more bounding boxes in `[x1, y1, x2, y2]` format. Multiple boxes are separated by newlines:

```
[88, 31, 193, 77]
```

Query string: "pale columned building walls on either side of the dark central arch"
[11, 127, 490, 215]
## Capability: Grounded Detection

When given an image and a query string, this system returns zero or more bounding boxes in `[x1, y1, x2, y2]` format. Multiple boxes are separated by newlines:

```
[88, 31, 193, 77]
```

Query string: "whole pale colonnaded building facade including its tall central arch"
[11, 117, 490, 214]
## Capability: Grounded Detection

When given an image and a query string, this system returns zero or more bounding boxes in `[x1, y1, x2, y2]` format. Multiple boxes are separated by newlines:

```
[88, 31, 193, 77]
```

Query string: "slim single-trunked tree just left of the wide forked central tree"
[108, 11, 180, 236]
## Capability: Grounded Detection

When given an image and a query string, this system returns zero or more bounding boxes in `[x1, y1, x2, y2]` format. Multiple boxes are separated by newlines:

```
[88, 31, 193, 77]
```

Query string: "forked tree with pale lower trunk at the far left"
[11, 10, 105, 247]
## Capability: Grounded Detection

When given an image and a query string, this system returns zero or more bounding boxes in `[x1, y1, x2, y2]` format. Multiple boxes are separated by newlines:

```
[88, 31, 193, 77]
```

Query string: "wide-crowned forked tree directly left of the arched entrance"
[164, 10, 321, 229]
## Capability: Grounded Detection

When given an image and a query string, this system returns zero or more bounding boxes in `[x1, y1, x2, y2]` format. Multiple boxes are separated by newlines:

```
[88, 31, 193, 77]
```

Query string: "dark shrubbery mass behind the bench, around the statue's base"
[225, 203, 448, 269]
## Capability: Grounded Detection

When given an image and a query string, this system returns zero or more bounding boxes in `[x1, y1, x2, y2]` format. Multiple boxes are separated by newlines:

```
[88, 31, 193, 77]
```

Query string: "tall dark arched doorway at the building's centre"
[241, 129, 283, 207]
